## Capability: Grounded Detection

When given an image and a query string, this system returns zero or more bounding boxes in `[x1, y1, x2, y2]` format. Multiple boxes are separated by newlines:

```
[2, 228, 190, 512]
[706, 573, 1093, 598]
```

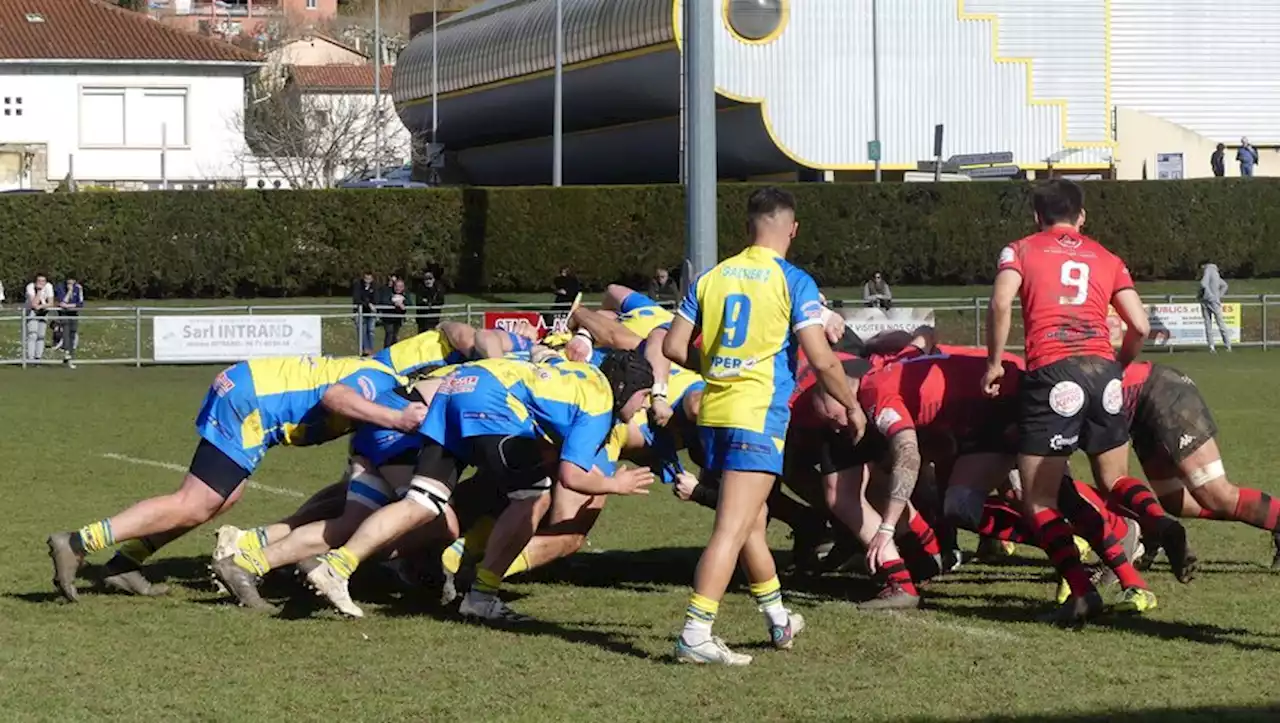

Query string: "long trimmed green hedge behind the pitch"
[0, 179, 1280, 298]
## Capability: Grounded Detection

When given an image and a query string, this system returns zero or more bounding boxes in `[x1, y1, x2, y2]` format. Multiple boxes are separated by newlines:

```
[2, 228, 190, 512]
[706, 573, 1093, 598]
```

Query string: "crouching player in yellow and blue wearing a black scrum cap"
[300, 353, 653, 621]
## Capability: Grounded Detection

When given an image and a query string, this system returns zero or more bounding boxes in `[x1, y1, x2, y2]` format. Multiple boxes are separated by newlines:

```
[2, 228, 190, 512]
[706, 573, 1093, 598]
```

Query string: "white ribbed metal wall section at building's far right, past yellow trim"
[1111, 0, 1280, 143]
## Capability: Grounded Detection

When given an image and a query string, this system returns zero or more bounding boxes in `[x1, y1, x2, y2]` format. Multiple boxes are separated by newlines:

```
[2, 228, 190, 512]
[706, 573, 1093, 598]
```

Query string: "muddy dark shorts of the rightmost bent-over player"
[1129, 363, 1217, 465]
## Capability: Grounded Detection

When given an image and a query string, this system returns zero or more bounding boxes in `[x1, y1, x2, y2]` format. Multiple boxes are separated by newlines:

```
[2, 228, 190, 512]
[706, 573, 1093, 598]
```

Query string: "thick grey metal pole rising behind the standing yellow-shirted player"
[684, 0, 718, 276]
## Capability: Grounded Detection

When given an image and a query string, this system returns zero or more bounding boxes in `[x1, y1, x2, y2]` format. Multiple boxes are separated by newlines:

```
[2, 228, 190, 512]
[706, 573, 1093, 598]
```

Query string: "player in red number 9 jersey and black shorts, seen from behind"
[982, 180, 1187, 624]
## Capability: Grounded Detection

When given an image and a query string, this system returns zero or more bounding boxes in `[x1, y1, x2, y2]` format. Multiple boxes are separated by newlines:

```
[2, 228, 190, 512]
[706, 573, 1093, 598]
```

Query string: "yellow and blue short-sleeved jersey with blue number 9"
[678, 246, 822, 438]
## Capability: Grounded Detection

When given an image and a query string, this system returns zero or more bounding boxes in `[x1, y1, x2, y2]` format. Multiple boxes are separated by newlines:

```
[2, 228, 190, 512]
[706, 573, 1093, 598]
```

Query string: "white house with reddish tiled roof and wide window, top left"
[0, 0, 260, 189]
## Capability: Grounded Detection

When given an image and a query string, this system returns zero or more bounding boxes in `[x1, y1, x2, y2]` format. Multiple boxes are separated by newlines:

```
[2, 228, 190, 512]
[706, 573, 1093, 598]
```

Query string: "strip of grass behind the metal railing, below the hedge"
[0, 279, 1280, 361]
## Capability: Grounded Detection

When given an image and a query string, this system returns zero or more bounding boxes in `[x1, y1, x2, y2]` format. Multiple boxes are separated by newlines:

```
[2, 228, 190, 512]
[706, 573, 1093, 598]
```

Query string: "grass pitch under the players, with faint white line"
[0, 352, 1280, 723]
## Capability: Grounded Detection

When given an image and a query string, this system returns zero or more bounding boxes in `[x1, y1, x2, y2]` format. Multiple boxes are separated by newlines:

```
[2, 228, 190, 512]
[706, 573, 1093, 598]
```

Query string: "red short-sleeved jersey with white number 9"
[997, 226, 1133, 371]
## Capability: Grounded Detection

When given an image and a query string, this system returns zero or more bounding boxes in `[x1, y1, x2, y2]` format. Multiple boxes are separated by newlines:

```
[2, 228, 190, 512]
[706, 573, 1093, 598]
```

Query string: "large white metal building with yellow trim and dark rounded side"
[396, 0, 1280, 184]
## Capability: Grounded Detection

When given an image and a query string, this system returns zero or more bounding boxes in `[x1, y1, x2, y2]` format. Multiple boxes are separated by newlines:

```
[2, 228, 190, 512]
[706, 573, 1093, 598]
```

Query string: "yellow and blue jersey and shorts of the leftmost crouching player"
[196, 357, 407, 473]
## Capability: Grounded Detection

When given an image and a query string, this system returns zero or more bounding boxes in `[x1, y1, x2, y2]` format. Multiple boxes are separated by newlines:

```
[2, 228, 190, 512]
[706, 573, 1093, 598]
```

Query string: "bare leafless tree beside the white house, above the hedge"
[236, 77, 404, 188]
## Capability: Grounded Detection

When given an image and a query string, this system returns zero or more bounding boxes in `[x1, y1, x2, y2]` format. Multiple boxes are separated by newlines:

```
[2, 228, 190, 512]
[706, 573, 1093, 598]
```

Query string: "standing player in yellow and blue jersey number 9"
[663, 188, 865, 665]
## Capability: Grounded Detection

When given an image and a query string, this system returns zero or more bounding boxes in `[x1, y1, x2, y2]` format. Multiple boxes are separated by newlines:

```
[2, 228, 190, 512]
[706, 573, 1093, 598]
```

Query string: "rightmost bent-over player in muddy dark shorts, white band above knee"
[1124, 362, 1280, 568]
